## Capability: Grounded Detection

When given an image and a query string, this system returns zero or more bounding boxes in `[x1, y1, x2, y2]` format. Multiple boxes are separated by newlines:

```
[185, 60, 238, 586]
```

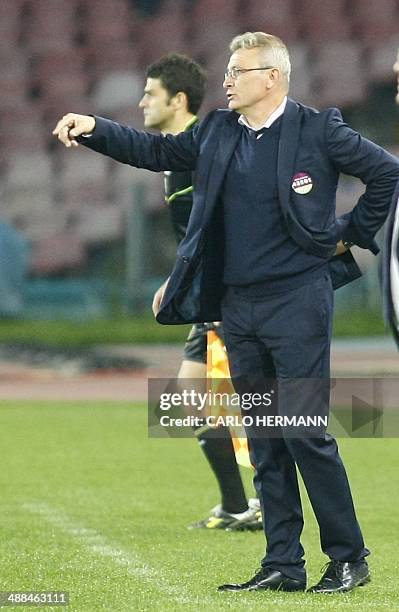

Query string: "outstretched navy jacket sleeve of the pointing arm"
[78, 117, 198, 172]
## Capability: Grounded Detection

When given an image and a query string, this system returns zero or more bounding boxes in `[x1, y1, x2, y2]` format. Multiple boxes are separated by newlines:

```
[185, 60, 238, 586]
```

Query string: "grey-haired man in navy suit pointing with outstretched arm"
[54, 32, 399, 593]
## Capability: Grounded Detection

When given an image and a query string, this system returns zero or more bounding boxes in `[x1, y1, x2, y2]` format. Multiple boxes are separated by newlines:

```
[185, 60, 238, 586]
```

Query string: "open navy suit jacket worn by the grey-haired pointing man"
[80, 100, 399, 324]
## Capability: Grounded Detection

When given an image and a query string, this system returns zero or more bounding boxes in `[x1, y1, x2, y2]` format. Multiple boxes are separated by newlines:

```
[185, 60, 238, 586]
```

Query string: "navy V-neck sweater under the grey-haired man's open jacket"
[222, 117, 326, 287]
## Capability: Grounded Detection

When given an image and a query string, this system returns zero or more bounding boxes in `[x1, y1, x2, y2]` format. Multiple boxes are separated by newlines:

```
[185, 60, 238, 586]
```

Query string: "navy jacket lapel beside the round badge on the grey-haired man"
[277, 98, 302, 216]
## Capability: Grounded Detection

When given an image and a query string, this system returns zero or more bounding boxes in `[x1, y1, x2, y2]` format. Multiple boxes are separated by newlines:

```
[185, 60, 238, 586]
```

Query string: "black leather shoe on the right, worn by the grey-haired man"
[308, 560, 370, 593]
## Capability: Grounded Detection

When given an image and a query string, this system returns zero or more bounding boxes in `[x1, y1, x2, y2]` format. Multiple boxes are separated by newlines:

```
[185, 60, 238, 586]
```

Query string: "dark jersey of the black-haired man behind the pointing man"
[164, 117, 198, 243]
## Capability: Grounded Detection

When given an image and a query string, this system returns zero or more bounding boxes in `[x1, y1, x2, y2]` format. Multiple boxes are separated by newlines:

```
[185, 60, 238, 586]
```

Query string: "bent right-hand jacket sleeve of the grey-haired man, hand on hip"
[326, 109, 399, 253]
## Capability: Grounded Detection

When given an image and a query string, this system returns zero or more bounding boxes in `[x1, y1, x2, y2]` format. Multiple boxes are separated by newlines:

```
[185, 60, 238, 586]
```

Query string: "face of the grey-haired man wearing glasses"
[223, 49, 271, 113]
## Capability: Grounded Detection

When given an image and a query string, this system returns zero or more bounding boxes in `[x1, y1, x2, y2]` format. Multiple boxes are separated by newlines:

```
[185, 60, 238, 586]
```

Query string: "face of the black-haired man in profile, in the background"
[139, 78, 175, 130]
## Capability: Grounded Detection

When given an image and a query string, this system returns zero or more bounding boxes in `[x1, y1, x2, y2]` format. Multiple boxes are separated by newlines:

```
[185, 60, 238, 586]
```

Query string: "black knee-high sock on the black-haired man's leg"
[198, 427, 248, 514]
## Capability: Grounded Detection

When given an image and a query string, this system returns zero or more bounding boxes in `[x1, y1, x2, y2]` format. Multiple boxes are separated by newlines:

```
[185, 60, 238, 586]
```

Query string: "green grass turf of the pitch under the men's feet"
[0, 401, 399, 612]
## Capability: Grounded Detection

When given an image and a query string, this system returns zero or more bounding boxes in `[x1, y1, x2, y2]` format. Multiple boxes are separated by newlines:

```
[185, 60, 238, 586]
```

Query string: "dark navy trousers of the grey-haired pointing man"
[222, 274, 369, 580]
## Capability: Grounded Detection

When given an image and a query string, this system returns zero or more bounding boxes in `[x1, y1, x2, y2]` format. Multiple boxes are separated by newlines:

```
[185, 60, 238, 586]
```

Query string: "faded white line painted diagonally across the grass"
[22, 503, 214, 604]
